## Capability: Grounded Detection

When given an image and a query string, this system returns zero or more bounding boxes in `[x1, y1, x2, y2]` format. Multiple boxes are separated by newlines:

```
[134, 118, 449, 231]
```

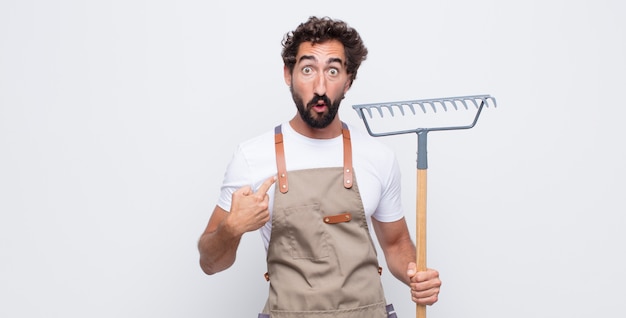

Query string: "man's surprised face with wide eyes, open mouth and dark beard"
[285, 40, 350, 128]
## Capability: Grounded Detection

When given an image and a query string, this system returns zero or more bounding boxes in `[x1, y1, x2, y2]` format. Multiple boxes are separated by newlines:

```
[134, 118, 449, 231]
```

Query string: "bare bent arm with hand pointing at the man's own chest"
[198, 176, 275, 275]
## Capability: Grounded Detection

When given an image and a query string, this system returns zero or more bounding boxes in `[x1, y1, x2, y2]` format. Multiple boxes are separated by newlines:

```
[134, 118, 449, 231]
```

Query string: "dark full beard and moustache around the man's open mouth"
[290, 87, 343, 128]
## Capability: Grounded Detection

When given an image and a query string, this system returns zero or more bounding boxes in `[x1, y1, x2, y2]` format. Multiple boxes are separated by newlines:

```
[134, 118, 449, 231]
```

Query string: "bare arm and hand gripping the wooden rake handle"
[372, 218, 441, 305]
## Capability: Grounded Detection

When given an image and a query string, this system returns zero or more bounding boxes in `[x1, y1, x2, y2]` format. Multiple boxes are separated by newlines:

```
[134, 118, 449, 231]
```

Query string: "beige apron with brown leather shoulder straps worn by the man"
[259, 124, 395, 318]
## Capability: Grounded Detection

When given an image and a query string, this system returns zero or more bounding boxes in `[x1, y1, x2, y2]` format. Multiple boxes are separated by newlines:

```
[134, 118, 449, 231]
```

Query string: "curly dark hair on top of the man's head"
[281, 16, 367, 85]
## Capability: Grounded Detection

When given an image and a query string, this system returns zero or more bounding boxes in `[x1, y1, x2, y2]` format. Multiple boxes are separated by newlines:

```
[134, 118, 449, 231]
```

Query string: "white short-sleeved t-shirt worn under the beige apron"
[217, 123, 404, 250]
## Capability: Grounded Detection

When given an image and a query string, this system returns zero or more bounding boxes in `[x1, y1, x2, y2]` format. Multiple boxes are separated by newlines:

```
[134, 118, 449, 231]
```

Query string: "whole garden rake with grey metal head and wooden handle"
[352, 95, 496, 318]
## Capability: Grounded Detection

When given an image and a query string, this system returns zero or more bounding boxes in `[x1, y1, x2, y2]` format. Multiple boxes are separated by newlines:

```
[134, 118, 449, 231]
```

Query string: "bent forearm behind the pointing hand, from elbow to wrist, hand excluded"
[198, 218, 243, 275]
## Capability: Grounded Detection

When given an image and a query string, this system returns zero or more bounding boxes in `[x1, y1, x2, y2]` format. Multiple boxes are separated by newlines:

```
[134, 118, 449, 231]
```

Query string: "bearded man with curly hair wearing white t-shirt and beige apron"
[198, 17, 441, 318]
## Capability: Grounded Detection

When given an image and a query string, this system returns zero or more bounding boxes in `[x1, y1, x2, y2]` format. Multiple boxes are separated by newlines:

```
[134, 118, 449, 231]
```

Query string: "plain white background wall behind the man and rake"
[0, 0, 626, 318]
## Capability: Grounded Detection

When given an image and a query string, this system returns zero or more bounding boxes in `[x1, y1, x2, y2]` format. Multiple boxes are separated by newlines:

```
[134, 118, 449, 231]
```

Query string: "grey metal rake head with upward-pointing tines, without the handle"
[352, 95, 496, 137]
